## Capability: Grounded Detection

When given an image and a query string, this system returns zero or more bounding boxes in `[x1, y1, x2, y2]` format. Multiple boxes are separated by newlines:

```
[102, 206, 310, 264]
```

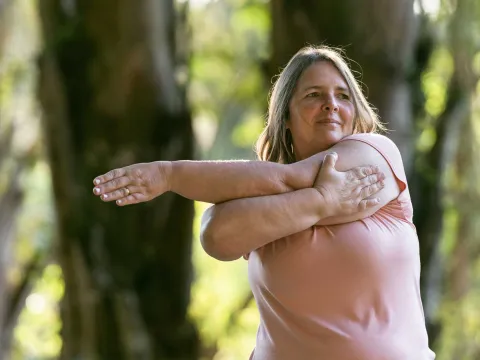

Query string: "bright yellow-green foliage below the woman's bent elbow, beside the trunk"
[189, 202, 259, 360]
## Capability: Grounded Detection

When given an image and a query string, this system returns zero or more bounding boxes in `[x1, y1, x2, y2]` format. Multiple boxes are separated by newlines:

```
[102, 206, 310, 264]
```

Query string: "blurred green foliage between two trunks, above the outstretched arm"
[189, 0, 270, 159]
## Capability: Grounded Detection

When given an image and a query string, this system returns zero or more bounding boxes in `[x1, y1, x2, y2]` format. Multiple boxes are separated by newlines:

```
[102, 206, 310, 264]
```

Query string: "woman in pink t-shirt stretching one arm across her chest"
[94, 47, 435, 360]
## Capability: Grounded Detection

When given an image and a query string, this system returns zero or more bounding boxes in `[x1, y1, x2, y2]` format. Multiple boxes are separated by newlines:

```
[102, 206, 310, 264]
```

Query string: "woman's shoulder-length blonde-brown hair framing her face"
[255, 46, 385, 164]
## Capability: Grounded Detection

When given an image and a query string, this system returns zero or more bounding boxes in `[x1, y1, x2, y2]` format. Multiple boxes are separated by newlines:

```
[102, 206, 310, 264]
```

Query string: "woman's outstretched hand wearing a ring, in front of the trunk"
[93, 161, 172, 206]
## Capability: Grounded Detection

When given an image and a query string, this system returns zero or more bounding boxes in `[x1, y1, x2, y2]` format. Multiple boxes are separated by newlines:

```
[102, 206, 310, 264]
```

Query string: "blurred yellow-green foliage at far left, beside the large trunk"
[0, 0, 58, 359]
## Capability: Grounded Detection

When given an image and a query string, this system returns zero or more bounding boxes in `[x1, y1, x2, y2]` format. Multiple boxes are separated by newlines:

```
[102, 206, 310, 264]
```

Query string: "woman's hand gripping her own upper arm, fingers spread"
[313, 153, 385, 217]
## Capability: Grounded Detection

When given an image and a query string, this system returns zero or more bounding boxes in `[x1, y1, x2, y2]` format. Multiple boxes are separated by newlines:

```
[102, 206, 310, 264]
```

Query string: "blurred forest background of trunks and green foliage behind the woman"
[0, 0, 480, 360]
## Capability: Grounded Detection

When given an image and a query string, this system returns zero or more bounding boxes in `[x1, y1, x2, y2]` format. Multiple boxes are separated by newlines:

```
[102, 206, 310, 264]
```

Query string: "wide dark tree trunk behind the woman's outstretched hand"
[39, 0, 197, 360]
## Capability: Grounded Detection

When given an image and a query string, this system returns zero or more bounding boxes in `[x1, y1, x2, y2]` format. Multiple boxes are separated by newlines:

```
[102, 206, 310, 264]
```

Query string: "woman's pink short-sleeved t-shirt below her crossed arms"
[248, 134, 435, 360]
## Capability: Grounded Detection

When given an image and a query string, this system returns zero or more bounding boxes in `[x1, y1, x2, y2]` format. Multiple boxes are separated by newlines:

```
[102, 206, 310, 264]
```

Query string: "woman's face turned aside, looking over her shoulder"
[287, 61, 355, 161]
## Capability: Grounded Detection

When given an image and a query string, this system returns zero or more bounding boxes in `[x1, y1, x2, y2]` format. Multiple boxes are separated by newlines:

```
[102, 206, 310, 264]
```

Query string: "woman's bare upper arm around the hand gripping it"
[318, 140, 403, 225]
